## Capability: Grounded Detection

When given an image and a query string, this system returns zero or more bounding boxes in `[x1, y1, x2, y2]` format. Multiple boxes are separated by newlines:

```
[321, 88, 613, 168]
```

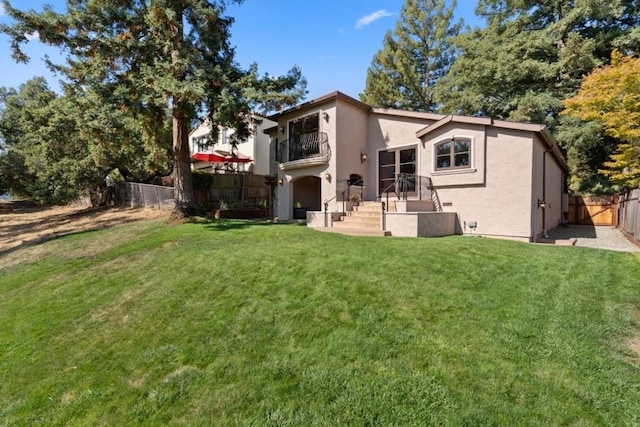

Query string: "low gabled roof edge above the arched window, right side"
[416, 114, 569, 172]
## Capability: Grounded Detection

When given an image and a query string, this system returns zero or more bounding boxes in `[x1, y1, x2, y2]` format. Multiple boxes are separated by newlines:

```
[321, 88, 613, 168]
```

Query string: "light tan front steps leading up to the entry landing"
[320, 202, 391, 236]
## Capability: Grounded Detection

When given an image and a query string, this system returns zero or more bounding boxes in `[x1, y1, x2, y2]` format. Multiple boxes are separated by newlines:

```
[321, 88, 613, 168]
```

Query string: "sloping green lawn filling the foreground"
[0, 221, 640, 426]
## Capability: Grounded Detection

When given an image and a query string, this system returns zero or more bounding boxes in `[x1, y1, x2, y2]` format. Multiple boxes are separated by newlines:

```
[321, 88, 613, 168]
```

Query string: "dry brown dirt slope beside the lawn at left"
[0, 201, 170, 256]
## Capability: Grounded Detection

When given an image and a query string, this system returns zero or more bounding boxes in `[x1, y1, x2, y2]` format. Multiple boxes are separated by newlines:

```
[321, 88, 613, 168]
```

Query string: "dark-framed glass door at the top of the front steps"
[378, 147, 416, 195]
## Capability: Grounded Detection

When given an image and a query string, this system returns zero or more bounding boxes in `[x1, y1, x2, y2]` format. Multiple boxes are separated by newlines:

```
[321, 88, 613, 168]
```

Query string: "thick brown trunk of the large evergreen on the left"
[173, 100, 195, 215]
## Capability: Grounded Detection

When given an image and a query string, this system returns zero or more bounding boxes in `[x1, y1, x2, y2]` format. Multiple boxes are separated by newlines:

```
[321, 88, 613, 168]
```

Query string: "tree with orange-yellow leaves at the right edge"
[563, 50, 640, 186]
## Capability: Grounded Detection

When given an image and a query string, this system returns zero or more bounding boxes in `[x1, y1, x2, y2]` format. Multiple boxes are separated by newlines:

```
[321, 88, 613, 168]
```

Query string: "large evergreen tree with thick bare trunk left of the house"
[0, 0, 305, 212]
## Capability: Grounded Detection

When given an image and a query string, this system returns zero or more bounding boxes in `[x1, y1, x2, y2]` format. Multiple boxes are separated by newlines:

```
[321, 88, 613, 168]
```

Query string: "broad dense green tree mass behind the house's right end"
[436, 0, 640, 190]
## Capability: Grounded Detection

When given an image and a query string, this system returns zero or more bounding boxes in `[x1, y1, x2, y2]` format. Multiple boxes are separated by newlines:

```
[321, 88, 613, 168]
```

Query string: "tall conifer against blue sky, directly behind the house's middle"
[360, 0, 462, 112]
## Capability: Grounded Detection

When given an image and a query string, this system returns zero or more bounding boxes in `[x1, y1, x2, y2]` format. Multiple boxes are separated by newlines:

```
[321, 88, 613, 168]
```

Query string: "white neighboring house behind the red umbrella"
[189, 113, 277, 175]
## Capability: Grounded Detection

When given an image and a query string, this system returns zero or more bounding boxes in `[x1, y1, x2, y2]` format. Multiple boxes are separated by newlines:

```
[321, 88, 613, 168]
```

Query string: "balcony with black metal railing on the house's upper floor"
[278, 132, 331, 170]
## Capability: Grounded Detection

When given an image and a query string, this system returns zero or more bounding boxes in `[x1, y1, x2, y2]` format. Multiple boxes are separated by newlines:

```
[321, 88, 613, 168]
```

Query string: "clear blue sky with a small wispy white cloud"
[0, 0, 479, 100]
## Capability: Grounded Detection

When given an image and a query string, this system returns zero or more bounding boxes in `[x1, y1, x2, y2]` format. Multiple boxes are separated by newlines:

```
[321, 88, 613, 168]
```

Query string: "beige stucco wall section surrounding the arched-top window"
[421, 123, 533, 241]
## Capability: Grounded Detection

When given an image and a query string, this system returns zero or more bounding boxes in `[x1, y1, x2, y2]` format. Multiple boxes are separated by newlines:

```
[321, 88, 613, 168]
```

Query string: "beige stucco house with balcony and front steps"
[266, 92, 568, 241]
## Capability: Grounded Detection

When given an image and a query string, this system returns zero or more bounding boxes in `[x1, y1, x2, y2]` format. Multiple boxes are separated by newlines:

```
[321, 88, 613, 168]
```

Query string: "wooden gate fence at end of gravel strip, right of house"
[567, 196, 618, 226]
